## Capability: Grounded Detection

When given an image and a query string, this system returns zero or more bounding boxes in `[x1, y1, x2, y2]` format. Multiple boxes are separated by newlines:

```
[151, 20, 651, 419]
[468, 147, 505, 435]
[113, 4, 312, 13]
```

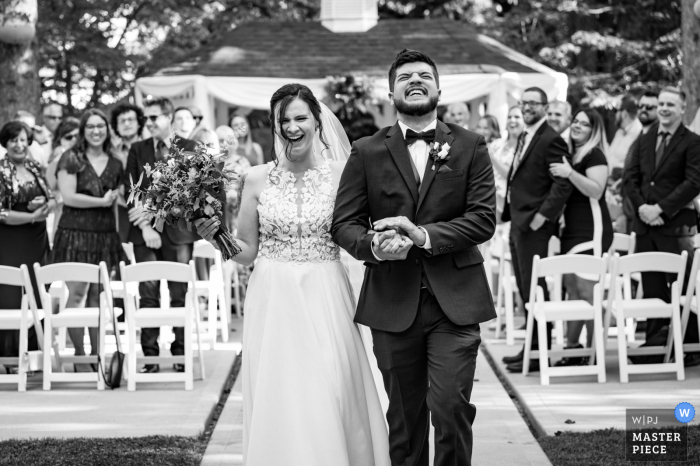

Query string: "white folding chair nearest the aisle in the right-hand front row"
[523, 255, 608, 385]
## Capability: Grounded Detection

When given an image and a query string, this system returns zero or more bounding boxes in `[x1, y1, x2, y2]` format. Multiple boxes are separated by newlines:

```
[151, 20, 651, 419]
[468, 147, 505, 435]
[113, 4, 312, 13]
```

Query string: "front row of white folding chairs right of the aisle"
[523, 252, 700, 385]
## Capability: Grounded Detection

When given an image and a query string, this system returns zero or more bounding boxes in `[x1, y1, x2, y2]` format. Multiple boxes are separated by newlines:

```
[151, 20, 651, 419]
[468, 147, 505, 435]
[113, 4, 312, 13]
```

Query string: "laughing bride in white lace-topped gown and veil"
[195, 84, 390, 466]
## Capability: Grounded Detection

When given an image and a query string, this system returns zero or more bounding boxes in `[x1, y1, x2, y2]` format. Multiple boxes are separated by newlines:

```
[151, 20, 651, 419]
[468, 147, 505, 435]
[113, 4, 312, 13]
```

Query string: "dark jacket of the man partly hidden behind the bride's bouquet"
[125, 138, 200, 245]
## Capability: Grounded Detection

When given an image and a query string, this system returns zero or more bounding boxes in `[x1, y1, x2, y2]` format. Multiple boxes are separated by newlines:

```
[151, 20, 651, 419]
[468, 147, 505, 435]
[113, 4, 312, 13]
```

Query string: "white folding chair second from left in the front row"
[34, 262, 118, 390]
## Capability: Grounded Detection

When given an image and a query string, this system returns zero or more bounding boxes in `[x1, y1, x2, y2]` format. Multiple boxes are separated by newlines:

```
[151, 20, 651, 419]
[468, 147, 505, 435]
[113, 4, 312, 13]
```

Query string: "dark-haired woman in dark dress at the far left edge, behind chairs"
[0, 121, 55, 373]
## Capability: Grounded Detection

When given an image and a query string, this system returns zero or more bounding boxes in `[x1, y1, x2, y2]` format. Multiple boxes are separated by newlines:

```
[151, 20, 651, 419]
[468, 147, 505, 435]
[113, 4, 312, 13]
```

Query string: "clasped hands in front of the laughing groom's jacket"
[370, 217, 426, 260]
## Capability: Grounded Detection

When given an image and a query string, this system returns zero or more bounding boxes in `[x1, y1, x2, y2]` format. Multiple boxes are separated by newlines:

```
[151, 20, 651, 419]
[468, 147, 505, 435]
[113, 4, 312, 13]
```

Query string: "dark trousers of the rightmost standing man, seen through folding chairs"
[635, 231, 698, 343]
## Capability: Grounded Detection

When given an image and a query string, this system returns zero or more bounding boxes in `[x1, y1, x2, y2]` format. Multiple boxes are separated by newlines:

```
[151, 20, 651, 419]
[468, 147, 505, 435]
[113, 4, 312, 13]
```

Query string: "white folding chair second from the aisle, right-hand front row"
[605, 251, 688, 383]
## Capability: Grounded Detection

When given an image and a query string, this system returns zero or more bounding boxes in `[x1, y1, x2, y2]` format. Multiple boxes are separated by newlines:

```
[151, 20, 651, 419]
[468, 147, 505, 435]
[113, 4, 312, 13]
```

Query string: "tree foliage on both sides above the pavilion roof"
[32, 0, 681, 109]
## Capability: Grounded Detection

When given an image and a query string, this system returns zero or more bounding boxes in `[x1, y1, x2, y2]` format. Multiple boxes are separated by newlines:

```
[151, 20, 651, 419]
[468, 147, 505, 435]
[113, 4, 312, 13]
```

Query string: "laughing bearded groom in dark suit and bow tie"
[332, 50, 496, 466]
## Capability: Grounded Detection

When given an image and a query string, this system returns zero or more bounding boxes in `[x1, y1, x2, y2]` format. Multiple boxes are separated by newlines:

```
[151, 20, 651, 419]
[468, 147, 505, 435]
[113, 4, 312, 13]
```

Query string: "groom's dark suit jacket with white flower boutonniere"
[332, 121, 496, 332]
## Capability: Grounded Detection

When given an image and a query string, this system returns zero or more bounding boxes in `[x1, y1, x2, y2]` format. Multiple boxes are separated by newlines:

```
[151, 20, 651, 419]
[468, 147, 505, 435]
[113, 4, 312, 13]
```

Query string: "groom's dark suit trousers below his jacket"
[372, 288, 481, 466]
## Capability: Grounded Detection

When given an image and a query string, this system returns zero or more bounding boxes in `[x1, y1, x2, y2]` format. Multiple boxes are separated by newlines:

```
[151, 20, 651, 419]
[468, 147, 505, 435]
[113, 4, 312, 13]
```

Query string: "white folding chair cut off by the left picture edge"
[0, 264, 44, 392]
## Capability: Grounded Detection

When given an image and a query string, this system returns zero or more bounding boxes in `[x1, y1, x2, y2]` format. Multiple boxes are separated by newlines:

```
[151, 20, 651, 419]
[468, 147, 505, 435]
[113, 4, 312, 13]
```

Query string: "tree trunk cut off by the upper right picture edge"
[681, 0, 700, 124]
